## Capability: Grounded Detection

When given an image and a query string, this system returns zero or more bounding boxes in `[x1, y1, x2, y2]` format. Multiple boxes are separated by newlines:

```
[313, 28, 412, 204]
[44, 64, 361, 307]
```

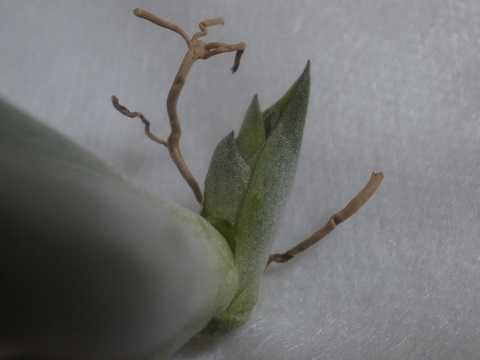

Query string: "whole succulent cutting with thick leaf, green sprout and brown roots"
[0, 9, 383, 360]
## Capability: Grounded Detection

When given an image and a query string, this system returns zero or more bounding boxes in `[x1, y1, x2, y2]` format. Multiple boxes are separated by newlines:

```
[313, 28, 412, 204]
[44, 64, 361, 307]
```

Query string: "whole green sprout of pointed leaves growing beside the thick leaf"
[203, 63, 310, 329]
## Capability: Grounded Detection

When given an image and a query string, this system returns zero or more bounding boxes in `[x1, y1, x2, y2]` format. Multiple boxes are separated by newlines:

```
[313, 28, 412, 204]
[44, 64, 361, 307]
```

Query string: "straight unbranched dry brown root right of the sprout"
[266, 172, 383, 267]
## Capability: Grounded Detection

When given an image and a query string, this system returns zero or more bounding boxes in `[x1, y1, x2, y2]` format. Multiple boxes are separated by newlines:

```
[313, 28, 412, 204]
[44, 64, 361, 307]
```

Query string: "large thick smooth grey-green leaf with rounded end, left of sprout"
[0, 102, 237, 360]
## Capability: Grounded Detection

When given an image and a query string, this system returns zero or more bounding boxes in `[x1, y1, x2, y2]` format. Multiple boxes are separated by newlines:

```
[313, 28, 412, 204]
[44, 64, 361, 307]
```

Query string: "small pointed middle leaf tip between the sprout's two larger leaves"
[237, 95, 265, 165]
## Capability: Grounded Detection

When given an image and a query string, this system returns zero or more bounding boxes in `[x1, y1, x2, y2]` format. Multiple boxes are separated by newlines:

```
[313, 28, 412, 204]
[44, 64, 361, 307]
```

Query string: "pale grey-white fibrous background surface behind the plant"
[0, 0, 480, 360]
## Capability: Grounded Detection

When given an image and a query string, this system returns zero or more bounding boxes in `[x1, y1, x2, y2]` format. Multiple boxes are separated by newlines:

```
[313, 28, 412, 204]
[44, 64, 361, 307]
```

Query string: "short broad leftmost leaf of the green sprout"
[202, 132, 251, 239]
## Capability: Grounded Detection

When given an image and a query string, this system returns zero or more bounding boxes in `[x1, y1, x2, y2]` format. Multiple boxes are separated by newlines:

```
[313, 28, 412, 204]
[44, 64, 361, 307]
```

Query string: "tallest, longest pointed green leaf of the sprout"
[214, 62, 310, 327]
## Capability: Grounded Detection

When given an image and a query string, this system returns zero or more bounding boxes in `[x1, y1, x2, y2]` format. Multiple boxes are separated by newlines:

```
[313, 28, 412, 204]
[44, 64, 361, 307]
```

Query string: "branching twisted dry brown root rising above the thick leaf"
[112, 9, 246, 203]
